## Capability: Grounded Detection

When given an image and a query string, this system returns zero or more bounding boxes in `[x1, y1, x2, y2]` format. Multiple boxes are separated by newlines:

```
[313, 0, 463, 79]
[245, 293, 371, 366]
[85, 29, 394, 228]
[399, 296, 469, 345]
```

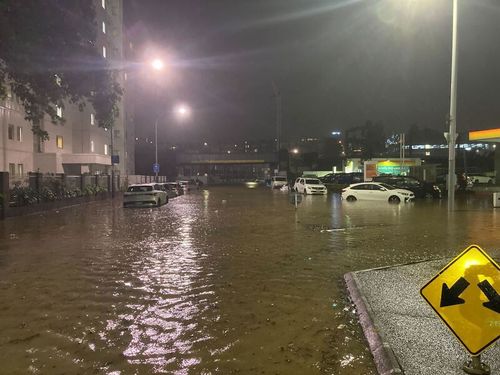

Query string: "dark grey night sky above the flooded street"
[124, 0, 500, 144]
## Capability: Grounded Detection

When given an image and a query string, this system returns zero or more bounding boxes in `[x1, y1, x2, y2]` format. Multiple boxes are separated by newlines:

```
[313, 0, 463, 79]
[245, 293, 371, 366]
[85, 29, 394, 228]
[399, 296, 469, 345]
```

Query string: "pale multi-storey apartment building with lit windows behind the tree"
[0, 0, 134, 177]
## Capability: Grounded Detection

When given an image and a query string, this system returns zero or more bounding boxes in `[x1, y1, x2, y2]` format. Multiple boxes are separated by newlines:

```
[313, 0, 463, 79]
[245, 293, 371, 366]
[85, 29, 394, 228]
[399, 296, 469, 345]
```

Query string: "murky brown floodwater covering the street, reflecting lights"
[0, 187, 500, 375]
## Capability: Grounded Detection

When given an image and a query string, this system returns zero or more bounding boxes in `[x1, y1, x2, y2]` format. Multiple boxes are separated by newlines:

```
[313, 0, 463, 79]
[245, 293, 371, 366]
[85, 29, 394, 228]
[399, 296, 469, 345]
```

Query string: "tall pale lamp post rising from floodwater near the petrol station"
[447, 0, 458, 211]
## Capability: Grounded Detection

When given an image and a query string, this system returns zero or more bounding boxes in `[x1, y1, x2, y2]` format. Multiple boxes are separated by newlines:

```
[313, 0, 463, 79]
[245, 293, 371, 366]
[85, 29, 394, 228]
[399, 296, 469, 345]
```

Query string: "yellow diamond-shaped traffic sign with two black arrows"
[420, 245, 500, 355]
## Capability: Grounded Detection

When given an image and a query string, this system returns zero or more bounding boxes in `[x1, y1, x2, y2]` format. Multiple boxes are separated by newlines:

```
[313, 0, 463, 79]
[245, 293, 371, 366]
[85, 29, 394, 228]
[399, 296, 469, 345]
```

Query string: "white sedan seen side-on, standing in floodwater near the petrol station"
[342, 182, 415, 203]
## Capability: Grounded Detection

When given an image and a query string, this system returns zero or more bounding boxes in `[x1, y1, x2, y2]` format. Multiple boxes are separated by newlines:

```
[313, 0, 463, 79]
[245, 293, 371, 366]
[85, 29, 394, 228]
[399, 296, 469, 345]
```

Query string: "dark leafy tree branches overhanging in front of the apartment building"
[0, 0, 122, 140]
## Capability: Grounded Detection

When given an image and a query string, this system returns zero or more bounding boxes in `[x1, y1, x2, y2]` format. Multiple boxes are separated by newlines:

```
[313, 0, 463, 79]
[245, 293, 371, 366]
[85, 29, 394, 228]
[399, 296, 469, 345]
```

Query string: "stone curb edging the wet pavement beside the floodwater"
[344, 272, 404, 375]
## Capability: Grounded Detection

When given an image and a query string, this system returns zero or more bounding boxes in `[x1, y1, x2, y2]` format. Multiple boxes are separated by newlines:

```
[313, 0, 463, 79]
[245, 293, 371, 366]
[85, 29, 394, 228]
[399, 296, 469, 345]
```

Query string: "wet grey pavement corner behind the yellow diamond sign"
[345, 260, 500, 375]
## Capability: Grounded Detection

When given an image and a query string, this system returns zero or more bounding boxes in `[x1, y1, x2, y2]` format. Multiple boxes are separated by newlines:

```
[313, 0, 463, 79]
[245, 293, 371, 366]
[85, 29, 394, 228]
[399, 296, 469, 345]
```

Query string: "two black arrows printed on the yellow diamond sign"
[440, 277, 500, 314]
